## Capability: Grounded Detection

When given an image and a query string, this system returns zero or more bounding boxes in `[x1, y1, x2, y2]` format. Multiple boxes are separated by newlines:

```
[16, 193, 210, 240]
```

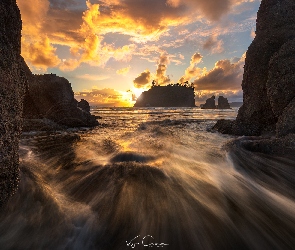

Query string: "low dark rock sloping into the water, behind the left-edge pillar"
[24, 71, 98, 127]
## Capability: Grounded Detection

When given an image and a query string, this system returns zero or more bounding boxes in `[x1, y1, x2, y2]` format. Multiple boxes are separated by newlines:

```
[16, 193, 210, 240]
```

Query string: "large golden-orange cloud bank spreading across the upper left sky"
[17, 0, 253, 72]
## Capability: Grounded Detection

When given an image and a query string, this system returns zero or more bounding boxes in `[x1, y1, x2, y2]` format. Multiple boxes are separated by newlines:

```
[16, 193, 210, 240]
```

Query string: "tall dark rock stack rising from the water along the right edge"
[214, 0, 295, 136]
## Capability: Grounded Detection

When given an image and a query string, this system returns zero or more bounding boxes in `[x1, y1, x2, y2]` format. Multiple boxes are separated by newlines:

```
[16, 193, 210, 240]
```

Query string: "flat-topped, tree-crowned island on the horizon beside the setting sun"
[134, 85, 195, 107]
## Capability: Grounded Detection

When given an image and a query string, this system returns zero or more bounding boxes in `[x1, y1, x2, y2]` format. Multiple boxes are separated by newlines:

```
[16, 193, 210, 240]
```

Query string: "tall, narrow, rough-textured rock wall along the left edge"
[0, 0, 26, 206]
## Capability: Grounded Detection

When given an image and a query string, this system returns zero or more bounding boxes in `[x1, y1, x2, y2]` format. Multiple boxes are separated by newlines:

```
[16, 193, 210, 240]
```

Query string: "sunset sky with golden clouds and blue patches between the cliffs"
[17, 0, 261, 106]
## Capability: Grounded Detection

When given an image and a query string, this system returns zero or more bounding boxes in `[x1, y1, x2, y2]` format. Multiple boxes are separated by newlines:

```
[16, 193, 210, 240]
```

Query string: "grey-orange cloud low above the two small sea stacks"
[194, 54, 245, 90]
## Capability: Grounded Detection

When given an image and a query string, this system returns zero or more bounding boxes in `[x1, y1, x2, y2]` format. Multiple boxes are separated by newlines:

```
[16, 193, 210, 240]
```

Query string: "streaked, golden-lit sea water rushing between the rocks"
[0, 108, 295, 250]
